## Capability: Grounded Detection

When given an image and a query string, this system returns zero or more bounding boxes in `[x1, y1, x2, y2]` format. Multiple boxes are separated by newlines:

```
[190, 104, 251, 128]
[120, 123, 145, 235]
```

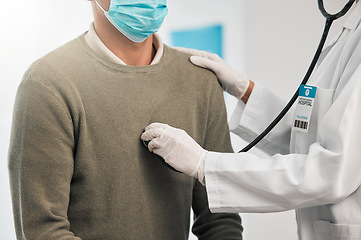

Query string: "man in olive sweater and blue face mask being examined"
[9, 0, 242, 240]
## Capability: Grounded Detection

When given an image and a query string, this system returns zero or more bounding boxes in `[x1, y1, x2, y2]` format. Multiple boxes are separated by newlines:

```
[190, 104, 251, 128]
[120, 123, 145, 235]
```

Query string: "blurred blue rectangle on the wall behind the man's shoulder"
[171, 25, 223, 57]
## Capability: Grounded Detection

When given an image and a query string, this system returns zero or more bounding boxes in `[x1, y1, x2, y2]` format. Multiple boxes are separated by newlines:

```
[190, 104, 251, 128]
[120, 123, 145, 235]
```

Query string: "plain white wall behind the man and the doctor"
[0, 0, 345, 240]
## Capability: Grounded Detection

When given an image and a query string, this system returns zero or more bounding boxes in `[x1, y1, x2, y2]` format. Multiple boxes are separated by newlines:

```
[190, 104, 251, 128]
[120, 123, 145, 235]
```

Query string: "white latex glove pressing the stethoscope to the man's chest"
[140, 123, 208, 182]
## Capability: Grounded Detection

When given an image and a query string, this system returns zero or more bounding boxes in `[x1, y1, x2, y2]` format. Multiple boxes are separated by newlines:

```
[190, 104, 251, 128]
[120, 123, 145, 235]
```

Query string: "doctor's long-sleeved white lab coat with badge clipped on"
[205, 3, 361, 240]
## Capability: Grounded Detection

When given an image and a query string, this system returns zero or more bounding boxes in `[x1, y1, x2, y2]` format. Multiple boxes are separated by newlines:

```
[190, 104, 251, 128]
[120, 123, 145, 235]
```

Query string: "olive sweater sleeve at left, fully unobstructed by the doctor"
[9, 77, 80, 240]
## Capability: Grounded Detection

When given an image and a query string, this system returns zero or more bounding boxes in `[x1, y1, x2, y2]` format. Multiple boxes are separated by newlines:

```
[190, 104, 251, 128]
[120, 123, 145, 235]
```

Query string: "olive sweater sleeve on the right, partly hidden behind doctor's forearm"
[192, 79, 243, 240]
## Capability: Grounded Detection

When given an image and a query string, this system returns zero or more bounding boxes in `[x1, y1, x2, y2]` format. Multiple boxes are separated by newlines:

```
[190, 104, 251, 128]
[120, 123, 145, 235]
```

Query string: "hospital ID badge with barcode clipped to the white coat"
[293, 85, 317, 133]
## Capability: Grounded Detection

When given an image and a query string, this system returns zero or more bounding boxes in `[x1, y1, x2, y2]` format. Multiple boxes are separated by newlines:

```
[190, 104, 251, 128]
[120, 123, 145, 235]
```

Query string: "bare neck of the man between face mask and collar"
[94, 22, 156, 66]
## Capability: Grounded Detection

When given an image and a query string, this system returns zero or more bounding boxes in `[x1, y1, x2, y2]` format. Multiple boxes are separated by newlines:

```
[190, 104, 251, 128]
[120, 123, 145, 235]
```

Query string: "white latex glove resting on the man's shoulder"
[174, 47, 249, 99]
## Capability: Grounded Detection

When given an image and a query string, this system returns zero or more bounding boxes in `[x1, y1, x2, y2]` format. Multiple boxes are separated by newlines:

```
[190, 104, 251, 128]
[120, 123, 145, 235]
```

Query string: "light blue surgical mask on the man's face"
[95, 0, 168, 43]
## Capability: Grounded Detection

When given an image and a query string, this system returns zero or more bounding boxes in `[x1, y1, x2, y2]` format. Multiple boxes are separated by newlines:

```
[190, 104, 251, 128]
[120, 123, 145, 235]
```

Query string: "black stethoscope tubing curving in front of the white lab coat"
[238, 0, 355, 153]
